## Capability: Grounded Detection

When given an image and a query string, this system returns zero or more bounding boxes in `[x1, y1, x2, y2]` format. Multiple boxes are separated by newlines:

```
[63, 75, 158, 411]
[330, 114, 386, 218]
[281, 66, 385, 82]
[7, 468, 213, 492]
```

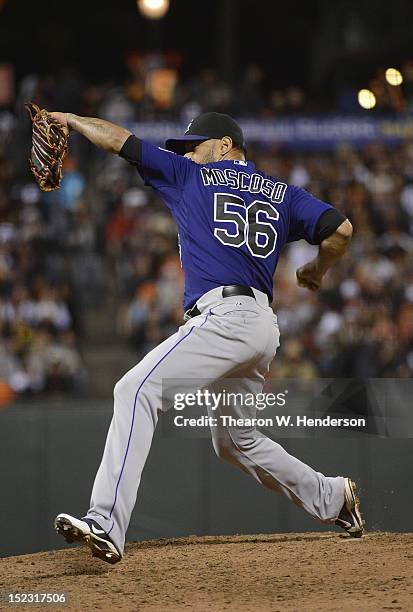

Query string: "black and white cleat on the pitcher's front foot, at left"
[54, 514, 122, 564]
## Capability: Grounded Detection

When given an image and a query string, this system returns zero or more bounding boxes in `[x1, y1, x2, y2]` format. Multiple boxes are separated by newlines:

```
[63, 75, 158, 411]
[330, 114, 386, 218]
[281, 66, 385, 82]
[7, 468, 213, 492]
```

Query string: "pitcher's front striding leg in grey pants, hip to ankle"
[77, 290, 276, 553]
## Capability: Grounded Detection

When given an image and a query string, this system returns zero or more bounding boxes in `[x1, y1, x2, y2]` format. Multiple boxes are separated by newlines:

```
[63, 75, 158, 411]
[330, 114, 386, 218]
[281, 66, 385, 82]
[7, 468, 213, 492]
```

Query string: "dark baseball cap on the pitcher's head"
[165, 113, 245, 155]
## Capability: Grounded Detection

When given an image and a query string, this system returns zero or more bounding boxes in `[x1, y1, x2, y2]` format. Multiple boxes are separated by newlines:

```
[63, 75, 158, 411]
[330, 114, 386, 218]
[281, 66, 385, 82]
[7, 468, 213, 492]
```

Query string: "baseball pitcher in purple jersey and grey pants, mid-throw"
[50, 112, 364, 563]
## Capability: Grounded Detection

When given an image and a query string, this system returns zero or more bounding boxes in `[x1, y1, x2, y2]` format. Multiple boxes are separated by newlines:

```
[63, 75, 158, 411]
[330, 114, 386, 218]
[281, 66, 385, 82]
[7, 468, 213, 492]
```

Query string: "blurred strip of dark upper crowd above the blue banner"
[0, 53, 413, 124]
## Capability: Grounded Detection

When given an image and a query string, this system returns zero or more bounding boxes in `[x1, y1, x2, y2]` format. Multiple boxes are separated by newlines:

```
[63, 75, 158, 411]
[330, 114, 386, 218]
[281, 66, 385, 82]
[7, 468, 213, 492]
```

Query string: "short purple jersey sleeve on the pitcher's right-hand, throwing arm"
[287, 187, 333, 244]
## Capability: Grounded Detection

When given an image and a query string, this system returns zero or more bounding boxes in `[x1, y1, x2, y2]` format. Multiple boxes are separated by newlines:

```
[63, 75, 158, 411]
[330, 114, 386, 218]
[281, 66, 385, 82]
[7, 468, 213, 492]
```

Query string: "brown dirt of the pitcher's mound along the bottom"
[0, 533, 413, 612]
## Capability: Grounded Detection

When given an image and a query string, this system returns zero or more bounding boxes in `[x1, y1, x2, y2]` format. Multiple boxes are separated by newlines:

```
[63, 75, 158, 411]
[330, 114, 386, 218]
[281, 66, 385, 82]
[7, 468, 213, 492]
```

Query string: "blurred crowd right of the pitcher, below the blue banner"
[261, 143, 413, 378]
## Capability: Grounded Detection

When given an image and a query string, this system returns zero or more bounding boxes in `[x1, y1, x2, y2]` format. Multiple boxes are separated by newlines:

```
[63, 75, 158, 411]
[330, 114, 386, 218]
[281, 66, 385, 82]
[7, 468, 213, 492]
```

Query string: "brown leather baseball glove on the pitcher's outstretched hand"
[25, 102, 68, 191]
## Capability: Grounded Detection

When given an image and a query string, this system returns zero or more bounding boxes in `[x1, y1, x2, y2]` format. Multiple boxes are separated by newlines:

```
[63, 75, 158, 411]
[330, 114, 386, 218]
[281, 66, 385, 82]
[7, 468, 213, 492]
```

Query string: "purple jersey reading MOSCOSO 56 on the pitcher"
[135, 141, 332, 309]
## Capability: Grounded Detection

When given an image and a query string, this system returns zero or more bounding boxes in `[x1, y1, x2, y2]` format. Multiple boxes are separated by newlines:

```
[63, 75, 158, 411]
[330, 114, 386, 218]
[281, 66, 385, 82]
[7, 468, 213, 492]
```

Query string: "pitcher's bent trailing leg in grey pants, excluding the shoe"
[209, 372, 344, 523]
